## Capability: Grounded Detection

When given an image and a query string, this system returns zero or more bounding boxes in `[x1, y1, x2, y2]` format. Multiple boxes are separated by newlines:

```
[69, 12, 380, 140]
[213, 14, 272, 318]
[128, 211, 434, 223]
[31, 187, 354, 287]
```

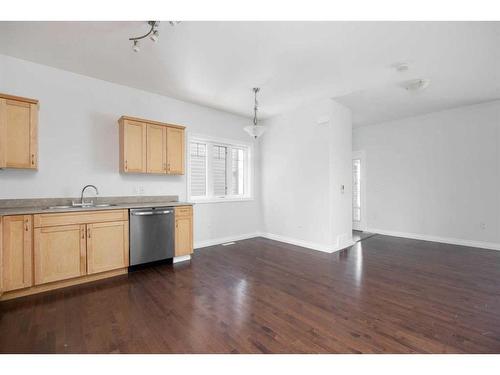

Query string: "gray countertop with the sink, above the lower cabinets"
[0, 196, 193, 216]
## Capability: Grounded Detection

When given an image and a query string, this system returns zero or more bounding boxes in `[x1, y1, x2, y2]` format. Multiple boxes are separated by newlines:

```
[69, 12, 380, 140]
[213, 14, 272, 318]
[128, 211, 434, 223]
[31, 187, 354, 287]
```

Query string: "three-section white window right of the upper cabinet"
[188, 137, 251, 202]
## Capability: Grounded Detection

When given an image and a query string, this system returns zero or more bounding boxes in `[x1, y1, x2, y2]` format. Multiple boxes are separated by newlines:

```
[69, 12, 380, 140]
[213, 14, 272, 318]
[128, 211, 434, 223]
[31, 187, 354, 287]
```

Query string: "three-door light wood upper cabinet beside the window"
[118, 116, 185, 175]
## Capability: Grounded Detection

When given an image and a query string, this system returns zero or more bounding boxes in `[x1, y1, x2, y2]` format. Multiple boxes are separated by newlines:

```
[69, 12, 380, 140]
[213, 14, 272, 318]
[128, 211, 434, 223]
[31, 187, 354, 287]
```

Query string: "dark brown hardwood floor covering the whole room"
[0, 235, 500, 353]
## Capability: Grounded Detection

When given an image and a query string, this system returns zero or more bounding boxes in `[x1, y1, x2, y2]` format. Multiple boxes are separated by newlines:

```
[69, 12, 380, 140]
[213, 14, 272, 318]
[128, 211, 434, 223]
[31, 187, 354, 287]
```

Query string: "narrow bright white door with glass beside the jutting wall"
[352, 151, 366, 231]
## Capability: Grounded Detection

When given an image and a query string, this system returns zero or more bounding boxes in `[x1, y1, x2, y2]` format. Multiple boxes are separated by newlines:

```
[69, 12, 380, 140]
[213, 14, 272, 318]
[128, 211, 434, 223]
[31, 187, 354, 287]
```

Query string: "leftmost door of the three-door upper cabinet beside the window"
[121, 120, 146, 173]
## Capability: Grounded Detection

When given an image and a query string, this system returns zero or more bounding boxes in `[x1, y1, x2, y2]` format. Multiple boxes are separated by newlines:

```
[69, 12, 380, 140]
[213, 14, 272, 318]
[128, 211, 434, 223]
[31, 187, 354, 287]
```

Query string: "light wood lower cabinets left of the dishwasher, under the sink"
[0, 209, 129, 300]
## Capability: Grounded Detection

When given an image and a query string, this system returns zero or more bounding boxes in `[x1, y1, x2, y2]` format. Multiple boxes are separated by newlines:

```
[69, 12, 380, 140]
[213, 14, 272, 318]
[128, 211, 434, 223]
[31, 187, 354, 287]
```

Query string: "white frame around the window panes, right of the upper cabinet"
[186, 134, 254, 203]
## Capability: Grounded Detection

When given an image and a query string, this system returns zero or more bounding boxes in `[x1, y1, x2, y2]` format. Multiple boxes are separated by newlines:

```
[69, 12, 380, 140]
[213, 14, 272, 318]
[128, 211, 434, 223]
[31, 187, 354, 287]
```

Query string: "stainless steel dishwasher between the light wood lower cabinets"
[129, 207, 175, 266]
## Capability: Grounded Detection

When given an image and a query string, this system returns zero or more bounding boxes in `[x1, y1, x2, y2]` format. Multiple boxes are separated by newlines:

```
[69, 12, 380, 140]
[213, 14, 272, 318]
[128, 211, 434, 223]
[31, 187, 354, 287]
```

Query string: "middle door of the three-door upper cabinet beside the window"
[146, 124, 167, 173]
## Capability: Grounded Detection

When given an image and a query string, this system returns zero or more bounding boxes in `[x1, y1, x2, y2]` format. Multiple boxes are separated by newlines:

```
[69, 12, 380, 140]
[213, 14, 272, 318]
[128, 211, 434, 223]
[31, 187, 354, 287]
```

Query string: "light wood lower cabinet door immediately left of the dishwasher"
[87, 221, 129, 274]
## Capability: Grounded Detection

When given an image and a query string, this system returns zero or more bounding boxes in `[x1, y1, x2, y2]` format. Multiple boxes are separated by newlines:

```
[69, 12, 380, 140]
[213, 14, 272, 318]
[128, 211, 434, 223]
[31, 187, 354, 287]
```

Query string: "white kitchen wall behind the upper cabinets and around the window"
[0, 55, 260, 244]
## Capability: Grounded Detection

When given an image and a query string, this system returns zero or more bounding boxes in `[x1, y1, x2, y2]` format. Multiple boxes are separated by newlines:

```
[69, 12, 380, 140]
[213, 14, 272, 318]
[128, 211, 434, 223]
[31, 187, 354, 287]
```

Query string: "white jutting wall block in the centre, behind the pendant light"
[261, 100, 352, 251]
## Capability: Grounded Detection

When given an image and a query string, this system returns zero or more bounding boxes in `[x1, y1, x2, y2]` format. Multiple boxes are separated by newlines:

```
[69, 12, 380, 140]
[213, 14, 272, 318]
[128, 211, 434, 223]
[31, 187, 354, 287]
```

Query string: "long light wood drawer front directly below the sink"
[33, 210, 128, 228]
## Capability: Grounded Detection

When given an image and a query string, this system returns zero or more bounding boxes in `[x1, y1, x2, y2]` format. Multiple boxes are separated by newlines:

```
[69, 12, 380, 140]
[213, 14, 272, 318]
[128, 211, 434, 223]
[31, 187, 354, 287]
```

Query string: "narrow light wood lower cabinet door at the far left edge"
[0, 215, 33, 294]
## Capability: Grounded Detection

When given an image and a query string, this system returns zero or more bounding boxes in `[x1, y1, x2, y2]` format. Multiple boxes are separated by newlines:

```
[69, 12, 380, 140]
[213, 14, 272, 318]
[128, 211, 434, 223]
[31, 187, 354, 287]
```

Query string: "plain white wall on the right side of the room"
[353, 101, 500, 248]
